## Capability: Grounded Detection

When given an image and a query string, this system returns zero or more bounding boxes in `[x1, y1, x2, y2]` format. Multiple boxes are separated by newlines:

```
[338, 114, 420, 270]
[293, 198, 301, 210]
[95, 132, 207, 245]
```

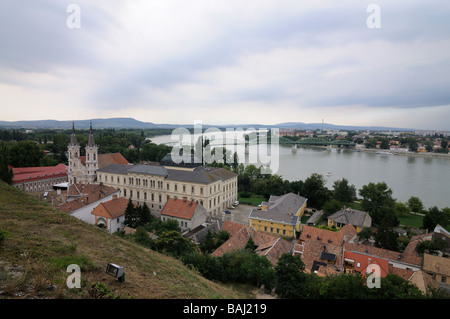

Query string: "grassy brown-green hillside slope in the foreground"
[0, 182, 248, 299]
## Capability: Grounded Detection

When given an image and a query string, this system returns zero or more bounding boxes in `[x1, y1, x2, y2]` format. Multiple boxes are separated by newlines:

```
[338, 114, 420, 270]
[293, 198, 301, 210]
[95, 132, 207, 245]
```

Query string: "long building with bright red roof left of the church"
[12, 164, 68, 192]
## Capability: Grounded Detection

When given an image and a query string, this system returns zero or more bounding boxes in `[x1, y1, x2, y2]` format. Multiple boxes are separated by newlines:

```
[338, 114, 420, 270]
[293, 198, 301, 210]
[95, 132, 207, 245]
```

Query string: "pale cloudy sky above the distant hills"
[0, 0, 450, 130]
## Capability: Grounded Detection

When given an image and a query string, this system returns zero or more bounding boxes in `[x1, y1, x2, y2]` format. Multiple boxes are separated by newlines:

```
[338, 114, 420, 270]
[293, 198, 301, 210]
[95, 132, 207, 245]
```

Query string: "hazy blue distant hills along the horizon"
[0, 118, 414, 131]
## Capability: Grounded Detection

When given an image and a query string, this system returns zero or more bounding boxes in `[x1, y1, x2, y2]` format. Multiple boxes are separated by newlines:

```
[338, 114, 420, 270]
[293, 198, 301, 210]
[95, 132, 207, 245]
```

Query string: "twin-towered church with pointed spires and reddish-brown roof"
[67, 122, 129, 186]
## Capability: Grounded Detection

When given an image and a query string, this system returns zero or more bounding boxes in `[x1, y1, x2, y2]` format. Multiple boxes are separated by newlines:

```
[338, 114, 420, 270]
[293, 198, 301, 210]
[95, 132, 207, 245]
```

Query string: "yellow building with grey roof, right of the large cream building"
[249, 193, 307, 237]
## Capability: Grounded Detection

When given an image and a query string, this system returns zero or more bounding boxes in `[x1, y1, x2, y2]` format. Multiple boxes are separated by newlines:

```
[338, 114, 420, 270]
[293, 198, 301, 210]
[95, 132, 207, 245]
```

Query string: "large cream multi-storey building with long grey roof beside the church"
[97, 164, 238, 216]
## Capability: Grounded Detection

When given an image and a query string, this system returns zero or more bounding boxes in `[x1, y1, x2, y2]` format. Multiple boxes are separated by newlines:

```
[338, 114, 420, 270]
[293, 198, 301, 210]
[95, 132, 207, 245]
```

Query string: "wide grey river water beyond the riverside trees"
[151, 135, 450, 209]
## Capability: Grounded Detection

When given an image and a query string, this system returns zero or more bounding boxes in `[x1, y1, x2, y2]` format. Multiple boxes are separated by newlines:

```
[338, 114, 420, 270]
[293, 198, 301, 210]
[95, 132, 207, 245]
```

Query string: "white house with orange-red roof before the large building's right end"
[161, 197, 206, 231]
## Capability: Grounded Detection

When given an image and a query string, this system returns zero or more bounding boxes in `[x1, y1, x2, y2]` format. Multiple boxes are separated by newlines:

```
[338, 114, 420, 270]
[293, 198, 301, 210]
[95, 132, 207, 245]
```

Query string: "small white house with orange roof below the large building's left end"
[91, 195, 128, 233]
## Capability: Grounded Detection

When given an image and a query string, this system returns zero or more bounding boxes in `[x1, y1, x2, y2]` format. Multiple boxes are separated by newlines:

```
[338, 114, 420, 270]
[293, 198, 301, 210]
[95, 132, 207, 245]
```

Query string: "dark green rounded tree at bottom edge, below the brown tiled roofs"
[275, 253, 307, 298]
